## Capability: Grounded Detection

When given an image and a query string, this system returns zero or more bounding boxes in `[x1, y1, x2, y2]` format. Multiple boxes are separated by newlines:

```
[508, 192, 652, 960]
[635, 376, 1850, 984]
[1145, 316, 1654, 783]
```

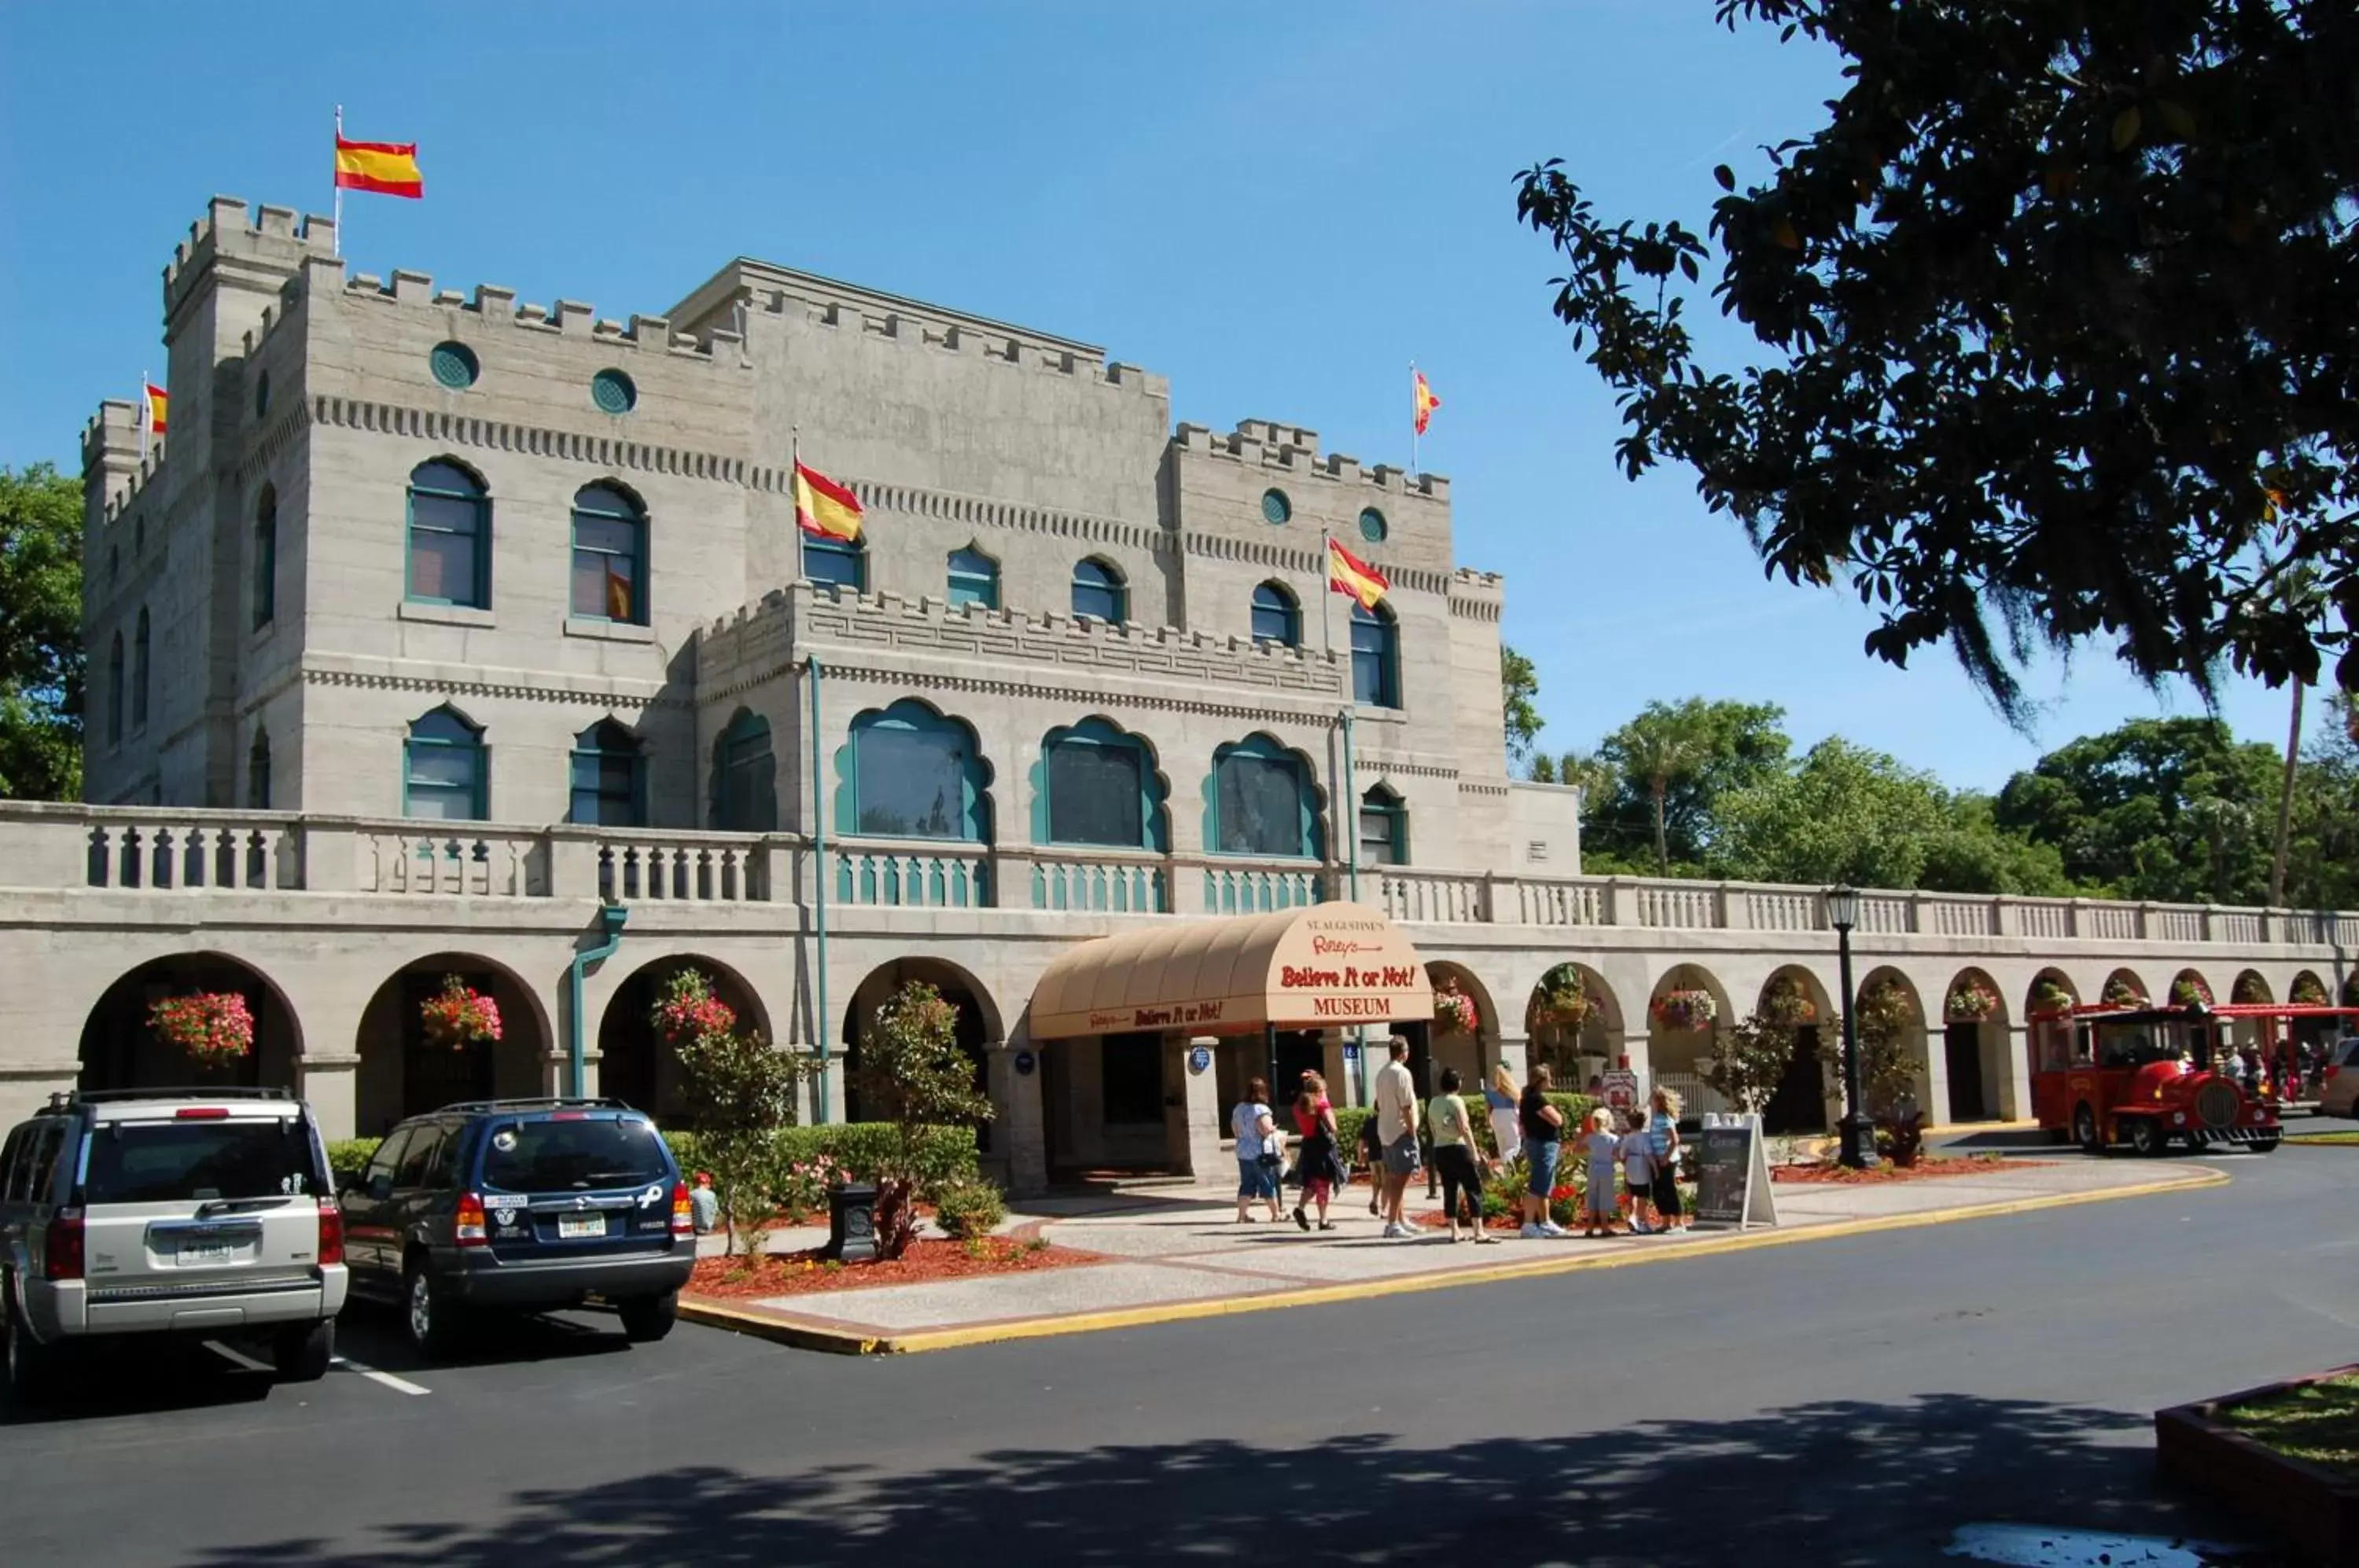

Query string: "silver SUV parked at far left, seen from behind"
[0, 1089, 347, 1398]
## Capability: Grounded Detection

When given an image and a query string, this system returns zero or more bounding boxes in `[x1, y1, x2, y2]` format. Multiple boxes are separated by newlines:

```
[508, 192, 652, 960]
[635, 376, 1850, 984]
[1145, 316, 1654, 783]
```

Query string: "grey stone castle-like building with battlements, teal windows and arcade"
[13, 198, 2359, 1181]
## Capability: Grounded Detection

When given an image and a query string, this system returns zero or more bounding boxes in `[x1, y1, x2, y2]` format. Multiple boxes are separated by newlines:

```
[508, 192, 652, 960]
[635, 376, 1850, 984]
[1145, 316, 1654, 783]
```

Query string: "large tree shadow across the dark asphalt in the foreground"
[198, 1367, 2272, 1568]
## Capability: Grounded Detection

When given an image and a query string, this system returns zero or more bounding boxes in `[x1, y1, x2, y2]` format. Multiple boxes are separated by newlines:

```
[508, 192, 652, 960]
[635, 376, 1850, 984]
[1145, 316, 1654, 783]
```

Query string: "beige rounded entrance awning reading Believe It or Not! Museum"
[1029, 903, 1434, 1040]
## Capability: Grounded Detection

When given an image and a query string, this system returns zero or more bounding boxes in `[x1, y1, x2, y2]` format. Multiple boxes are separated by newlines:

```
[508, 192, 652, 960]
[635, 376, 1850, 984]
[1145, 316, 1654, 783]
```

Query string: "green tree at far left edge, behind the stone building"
[0, 462, 85, 799]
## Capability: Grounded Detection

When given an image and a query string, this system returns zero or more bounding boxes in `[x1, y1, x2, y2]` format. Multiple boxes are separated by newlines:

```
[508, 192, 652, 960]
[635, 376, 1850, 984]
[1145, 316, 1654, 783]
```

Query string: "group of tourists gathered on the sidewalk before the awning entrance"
[1229, 1035, 1687, 1245]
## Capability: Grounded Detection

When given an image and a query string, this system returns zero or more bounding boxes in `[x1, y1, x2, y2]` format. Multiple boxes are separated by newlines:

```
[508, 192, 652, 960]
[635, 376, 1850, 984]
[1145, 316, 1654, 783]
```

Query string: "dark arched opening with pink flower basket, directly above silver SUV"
[75, 952, 302, 1089]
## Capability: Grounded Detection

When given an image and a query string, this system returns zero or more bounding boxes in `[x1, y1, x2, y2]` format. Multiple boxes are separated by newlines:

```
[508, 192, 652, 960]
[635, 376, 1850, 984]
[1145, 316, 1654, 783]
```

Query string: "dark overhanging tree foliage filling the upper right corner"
[1517, 0, 2359, 720]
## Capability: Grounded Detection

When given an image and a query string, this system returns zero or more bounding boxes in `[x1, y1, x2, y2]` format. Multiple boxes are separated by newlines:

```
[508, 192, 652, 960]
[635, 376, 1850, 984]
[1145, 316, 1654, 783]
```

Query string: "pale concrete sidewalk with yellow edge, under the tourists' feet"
[679, 1155, 2227, 1353]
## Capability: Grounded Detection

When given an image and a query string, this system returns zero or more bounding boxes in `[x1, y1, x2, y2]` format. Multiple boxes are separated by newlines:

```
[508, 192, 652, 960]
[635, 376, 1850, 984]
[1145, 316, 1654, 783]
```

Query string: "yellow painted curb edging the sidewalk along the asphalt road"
[679, 1167, 2229, 1356]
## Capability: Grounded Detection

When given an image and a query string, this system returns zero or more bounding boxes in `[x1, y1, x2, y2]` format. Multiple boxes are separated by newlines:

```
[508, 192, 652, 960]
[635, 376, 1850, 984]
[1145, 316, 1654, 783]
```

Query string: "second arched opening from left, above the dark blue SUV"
[354, 952, 552, 1136]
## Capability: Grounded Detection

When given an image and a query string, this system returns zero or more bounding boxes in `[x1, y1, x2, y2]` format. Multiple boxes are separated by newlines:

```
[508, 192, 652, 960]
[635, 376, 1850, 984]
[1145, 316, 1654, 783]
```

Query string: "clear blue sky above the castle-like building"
[0, 0, 2317, 787]
